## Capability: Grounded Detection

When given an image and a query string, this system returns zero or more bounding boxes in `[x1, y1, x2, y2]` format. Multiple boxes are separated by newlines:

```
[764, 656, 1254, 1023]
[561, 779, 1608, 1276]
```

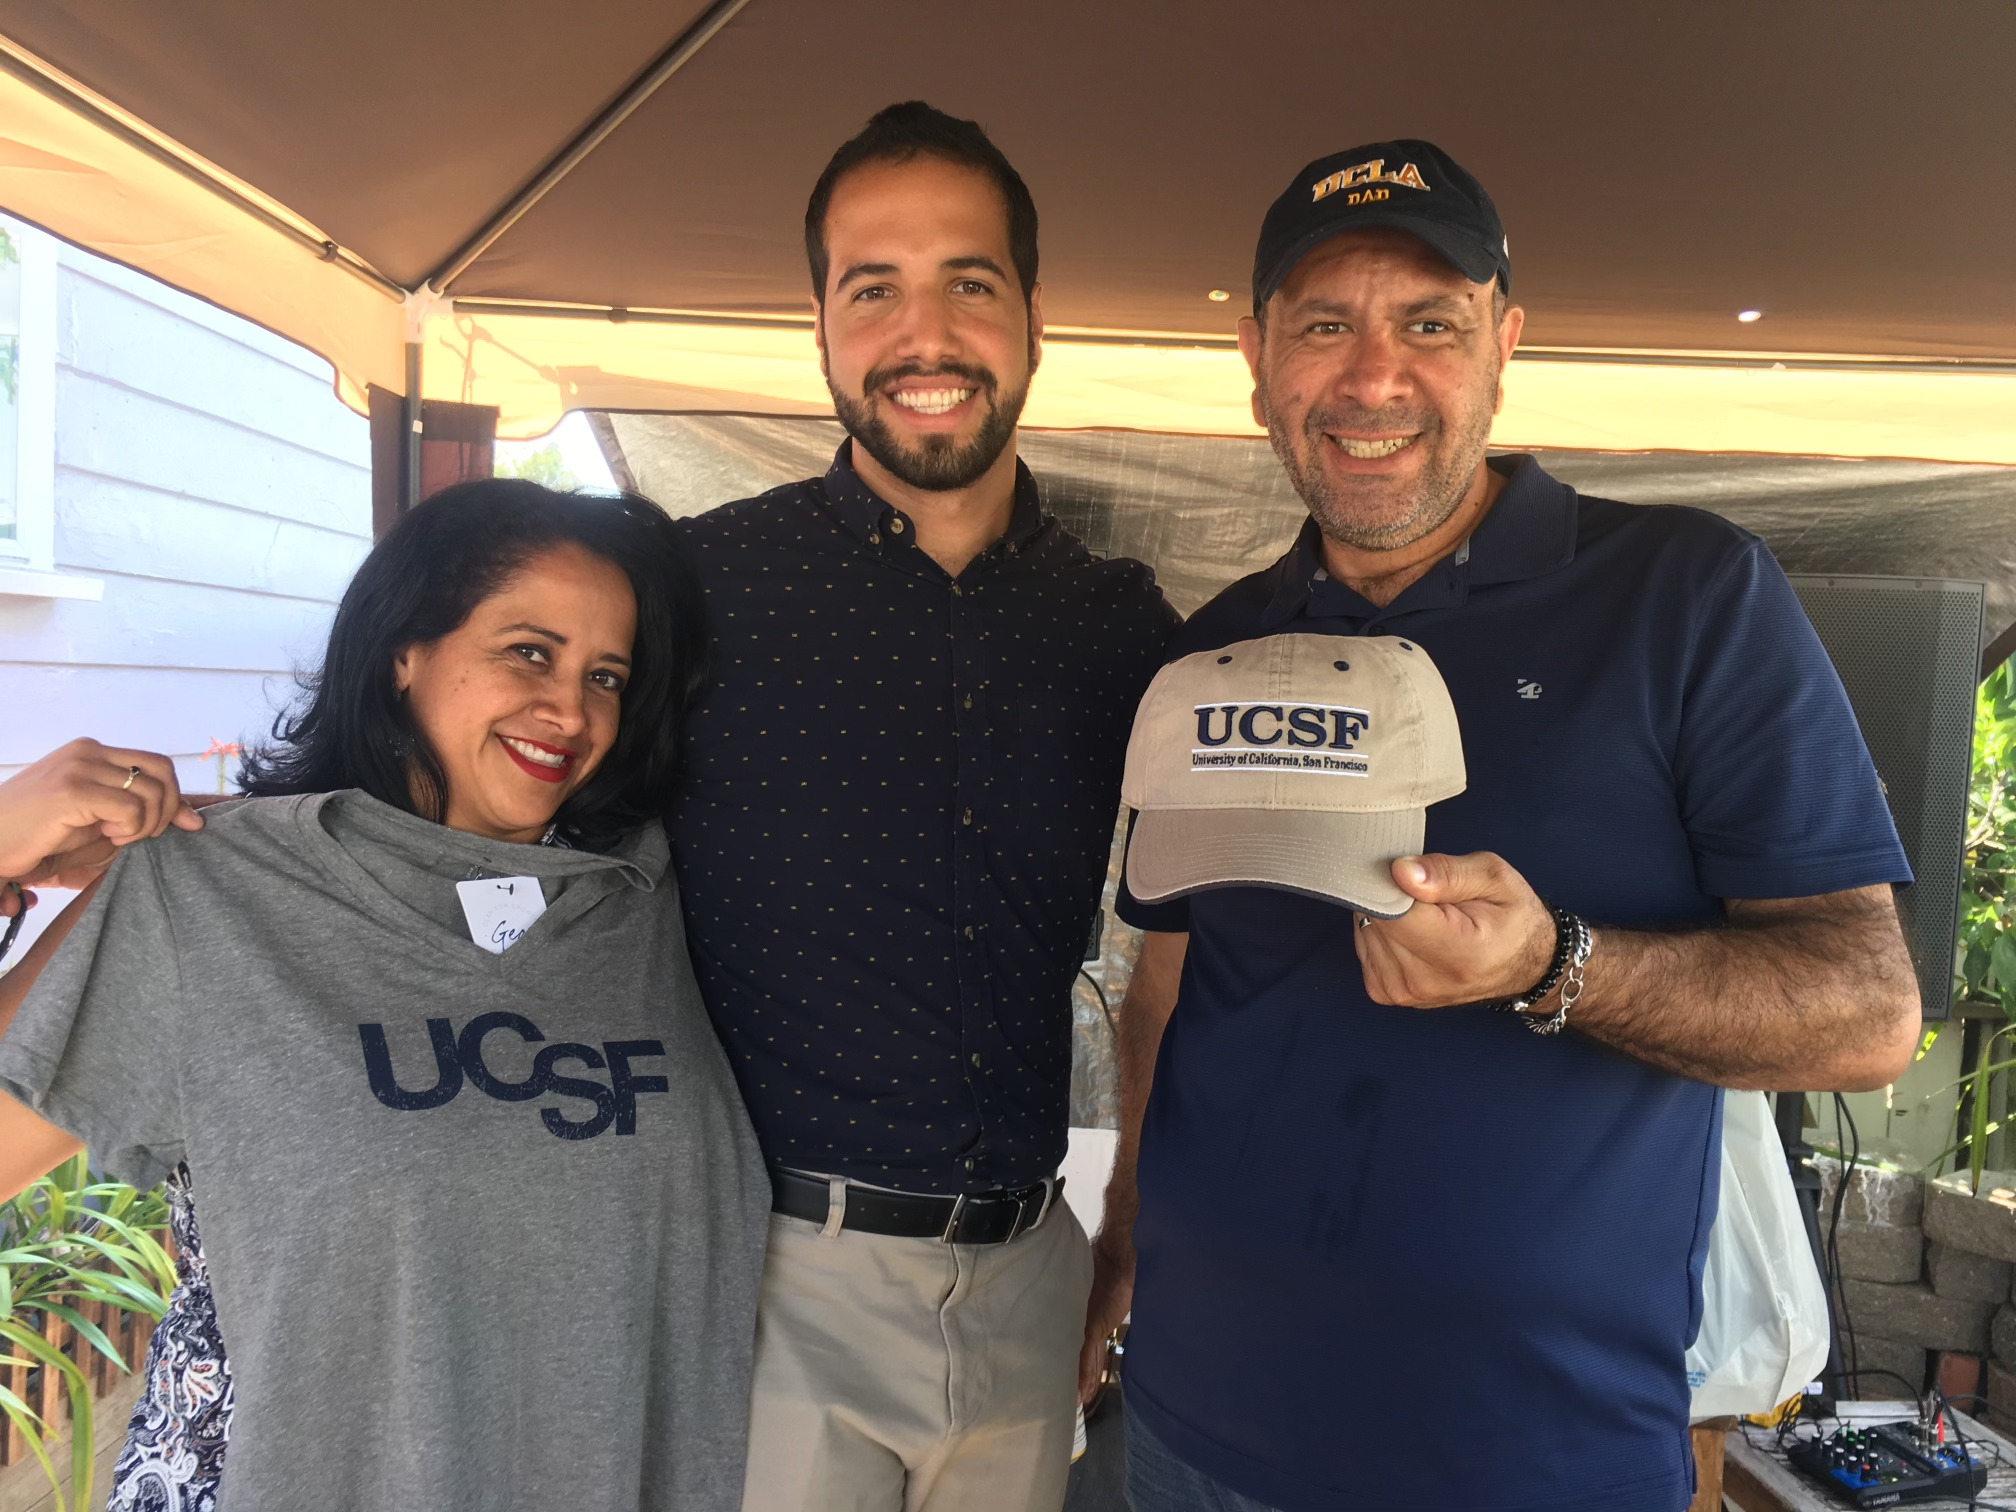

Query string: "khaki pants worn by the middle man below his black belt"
[742, 1198, 1093, 1512]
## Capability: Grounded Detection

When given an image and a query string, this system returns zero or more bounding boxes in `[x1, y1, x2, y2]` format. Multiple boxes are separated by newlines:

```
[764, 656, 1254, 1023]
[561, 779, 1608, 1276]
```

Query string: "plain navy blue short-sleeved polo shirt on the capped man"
[1121, 458, 1909, 1512]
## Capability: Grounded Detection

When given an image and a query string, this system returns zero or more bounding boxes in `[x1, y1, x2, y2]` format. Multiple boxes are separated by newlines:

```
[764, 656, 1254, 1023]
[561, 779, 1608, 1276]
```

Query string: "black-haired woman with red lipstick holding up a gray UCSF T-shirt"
[0, 480, 770, 1512]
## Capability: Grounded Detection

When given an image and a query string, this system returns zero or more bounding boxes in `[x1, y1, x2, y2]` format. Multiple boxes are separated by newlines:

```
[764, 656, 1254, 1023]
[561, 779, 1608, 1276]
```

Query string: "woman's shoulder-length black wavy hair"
[238, 478, 708, 851]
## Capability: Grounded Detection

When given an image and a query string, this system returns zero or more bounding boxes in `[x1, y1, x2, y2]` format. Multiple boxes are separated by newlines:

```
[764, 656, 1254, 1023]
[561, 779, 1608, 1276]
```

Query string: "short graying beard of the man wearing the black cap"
[1254, 377, 1498, 550]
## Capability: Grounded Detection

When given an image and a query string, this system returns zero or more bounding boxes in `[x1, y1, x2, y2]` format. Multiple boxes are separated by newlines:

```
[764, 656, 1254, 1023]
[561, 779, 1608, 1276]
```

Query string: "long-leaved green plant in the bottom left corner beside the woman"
[0, 1155, 175, 1512]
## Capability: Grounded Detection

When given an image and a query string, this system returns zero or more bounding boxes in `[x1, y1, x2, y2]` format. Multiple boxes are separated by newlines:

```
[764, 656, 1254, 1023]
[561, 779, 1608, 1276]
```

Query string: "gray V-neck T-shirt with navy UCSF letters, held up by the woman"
[0, 792, 770, 1512]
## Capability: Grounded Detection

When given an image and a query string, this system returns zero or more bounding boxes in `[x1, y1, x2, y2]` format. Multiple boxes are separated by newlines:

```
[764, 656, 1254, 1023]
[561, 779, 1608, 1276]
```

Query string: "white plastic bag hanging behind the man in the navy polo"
[1687, 1093, 1826, 1423]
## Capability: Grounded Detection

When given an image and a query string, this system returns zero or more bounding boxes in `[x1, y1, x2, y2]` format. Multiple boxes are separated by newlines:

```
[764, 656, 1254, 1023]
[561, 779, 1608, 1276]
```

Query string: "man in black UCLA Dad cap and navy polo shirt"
[1085, 141, 1917, 1512]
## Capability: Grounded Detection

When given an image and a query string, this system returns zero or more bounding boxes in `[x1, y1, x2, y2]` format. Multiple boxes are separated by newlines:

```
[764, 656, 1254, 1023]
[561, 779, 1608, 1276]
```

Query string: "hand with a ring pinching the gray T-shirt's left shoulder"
[0, 740, 204, 895]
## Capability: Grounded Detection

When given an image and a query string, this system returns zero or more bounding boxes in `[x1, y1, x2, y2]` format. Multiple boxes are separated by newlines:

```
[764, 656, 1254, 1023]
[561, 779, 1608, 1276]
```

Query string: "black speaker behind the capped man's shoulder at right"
[1792, 577, 1984, 1018]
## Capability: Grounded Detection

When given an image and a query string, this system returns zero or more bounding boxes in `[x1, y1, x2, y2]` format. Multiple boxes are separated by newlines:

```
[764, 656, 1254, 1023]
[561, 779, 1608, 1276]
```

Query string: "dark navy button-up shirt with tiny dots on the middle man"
[671, 446, 1177, 1193]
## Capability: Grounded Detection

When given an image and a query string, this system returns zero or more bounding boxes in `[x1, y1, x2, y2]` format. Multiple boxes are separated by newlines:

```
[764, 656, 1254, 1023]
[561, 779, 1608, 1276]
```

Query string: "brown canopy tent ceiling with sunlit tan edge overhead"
[0, 0, 2016, 462]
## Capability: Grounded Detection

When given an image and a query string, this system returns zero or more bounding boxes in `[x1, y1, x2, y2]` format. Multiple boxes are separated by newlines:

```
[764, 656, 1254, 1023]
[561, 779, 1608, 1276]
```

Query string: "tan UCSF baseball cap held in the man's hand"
[1121, 635, 1466, 919]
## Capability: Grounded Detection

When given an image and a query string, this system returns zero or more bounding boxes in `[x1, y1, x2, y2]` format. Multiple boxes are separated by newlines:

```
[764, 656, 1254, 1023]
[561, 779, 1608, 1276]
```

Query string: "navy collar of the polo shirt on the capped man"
[1262, 454, 1579, 629]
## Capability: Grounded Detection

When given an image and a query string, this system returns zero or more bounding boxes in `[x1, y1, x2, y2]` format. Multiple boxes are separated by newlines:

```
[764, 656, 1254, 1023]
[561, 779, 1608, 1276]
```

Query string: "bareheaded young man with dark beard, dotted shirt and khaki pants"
[671, 103, 1175, 1512]
